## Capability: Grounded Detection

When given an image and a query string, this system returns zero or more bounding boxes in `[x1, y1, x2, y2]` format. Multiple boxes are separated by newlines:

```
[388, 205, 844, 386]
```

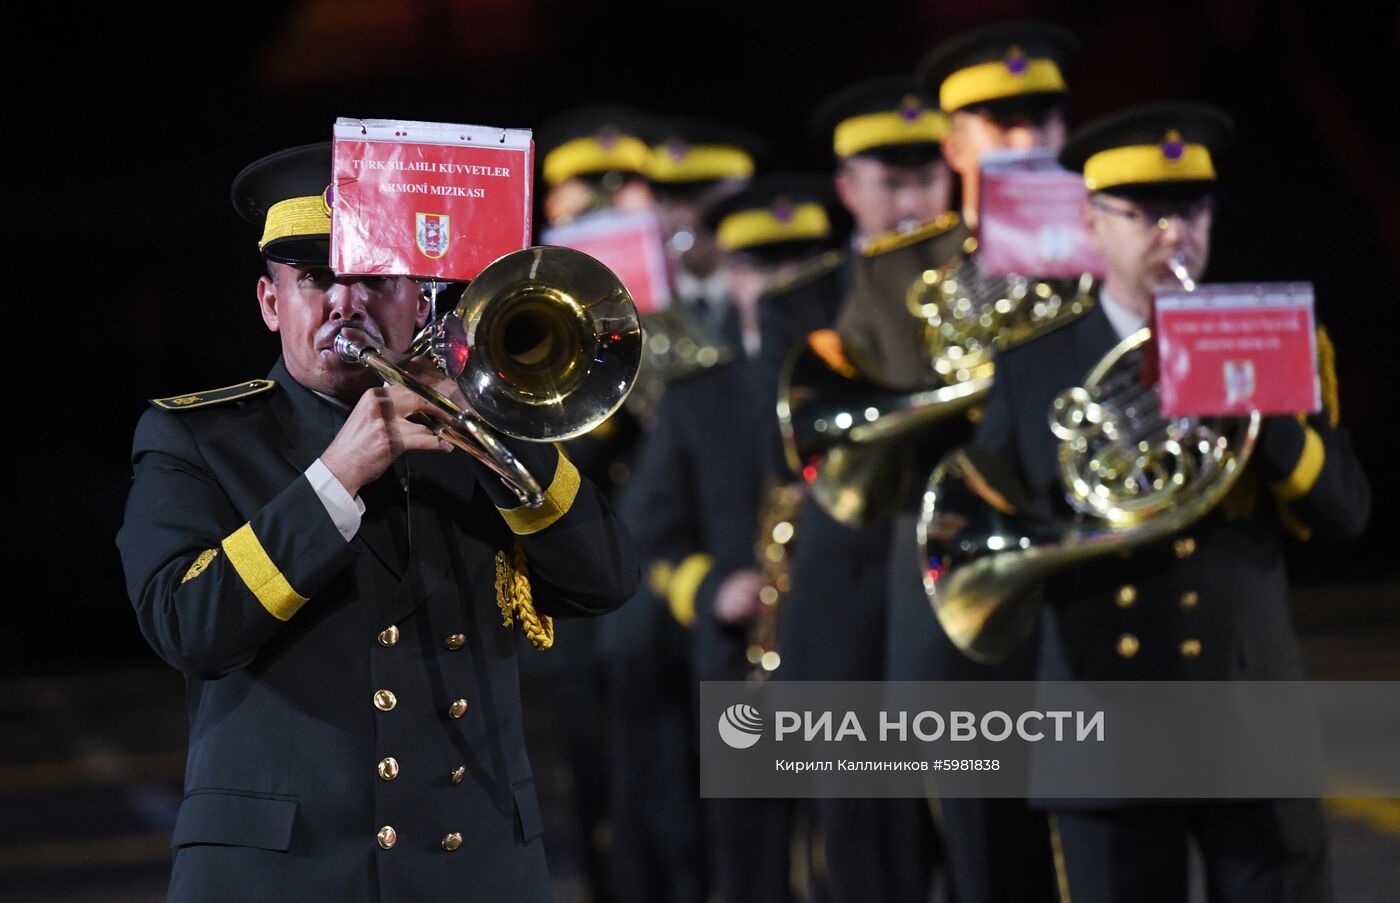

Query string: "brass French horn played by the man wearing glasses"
[917, 253, 1260, 662]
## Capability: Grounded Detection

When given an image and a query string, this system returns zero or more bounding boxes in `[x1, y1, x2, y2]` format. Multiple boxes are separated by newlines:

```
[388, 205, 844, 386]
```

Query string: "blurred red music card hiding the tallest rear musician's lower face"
[977, 151, 1103, 279]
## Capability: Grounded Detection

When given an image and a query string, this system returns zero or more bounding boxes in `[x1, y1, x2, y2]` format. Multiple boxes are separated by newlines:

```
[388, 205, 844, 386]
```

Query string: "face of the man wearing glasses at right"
[1082, 192, 1212, 297]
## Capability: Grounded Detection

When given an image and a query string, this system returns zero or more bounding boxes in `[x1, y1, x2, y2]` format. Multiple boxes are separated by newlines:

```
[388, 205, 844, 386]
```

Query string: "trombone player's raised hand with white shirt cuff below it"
[321, 385, 452, 496]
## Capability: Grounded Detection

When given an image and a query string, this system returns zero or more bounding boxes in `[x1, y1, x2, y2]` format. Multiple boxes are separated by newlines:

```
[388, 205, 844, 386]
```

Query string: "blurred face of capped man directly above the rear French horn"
[836, 157, 952, 237]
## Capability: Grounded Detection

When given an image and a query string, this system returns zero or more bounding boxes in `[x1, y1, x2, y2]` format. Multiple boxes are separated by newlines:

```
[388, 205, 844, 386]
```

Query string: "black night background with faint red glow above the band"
[13, 0, 1400, 675]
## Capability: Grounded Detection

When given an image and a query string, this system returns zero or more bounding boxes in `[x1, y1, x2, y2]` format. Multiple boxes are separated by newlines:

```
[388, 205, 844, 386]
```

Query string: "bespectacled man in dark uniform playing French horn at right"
[974, 104, 1371, 903]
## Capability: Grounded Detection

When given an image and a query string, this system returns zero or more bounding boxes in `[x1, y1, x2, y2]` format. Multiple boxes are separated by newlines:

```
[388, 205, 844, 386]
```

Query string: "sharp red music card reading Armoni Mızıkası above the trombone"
[330, 119, 535, 281]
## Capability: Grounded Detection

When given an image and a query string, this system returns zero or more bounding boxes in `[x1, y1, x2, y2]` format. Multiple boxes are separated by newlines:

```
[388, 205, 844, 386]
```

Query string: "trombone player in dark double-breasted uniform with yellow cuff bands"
[118, 144, 637, 902]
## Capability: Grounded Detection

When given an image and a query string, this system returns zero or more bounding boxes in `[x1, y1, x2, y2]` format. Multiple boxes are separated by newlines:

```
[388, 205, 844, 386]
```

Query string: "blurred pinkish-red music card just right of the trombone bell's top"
[540, 210, 671, 314]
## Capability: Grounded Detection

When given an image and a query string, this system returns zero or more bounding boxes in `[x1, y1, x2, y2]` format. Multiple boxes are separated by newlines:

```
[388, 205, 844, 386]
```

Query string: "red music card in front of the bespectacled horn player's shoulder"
[1155, 283, 1322, 416]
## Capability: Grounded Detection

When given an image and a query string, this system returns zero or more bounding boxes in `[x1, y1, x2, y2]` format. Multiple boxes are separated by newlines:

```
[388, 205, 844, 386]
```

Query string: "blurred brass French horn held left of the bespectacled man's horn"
[778, 239, 1093, 525]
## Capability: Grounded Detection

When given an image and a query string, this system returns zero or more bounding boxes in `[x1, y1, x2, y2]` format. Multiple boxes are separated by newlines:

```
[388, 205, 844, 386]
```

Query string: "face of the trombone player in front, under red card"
[258, 263, 430, 403]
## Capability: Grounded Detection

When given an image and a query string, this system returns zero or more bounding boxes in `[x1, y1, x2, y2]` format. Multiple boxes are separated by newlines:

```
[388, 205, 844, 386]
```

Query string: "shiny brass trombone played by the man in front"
[336, 246, 641, 507]
